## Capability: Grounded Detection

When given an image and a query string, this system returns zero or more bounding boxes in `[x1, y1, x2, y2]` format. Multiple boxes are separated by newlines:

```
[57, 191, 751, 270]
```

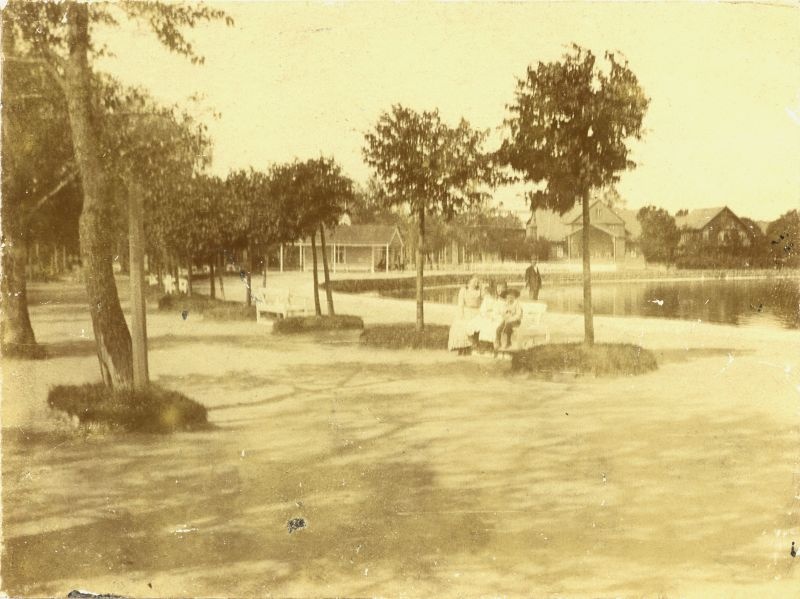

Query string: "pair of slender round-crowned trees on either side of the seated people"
[364, 46, 649, 344]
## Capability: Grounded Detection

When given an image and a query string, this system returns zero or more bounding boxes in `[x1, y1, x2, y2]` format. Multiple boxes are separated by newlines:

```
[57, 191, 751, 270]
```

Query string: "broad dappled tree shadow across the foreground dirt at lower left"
[2, 426, 490, 595]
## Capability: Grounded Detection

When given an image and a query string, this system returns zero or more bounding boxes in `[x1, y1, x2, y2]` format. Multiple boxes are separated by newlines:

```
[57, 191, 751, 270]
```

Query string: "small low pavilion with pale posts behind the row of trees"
[298, 225, 405, 272]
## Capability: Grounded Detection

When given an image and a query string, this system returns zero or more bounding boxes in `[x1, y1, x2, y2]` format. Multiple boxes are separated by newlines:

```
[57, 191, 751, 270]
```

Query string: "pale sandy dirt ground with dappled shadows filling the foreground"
[2, 275, 800, 598]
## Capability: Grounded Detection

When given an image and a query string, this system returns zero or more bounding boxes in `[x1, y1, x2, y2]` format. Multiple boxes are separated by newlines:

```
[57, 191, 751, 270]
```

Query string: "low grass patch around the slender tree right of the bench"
[511, 343, 658, 376]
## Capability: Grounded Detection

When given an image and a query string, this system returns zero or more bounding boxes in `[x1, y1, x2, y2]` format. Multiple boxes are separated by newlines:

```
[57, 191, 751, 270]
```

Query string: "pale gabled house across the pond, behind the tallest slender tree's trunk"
[528, 199, 641, 262]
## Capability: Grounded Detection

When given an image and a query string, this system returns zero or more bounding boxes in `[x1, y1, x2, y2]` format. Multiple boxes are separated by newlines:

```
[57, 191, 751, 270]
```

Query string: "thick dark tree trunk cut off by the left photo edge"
[0, 221, 44, 358]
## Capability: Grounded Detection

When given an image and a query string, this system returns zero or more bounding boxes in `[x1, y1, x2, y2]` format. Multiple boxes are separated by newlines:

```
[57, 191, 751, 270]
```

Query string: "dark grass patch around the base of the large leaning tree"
[47, 383, 209, 433]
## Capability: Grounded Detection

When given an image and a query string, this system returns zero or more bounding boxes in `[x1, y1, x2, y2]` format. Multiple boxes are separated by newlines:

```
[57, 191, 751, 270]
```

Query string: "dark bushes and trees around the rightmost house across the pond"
[637, 206, 800, 268]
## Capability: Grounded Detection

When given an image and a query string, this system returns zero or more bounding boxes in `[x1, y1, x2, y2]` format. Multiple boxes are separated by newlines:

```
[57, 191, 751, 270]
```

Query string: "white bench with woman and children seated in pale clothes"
[447, 277, 550, 356]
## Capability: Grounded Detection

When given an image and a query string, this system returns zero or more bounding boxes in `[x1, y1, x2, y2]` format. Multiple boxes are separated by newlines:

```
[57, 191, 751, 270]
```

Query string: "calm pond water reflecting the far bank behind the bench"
[386, 279, 800, 328]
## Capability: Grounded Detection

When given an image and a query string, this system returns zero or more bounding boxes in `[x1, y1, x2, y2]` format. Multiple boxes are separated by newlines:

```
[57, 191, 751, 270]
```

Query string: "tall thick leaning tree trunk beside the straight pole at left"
[64, 2, 133, 387]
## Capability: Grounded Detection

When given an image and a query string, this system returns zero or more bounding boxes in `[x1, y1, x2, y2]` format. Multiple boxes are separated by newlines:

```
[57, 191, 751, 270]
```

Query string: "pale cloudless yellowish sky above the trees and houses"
[97, 2, 800, 220]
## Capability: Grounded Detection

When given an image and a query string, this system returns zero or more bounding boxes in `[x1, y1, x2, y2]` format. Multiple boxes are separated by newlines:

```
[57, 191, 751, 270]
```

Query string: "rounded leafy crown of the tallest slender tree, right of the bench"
[499, 46, 649, 214]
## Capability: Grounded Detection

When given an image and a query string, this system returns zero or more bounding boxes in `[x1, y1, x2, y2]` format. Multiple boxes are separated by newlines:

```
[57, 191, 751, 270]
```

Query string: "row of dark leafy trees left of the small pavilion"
[145, 157, 353, 313]
